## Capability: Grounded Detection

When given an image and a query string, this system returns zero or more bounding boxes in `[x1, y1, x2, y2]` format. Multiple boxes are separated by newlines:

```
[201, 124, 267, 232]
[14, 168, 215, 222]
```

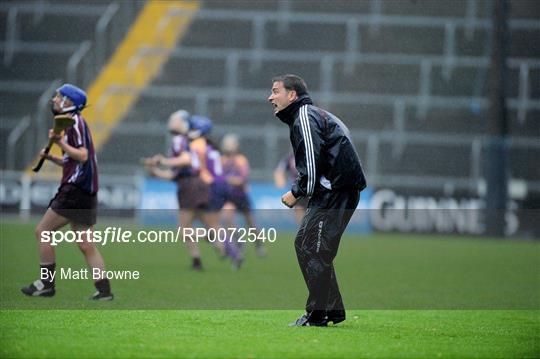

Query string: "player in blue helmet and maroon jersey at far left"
[21, 84, 113, 300]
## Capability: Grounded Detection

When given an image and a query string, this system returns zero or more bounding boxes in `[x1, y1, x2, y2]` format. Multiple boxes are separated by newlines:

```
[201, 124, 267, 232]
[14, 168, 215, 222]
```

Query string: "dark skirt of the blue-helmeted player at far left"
[49, 183, 97, 226]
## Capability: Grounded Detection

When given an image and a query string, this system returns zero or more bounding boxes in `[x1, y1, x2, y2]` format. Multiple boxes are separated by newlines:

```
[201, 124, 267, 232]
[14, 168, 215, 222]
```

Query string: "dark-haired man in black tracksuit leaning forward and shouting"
[268, 75, 366, 326]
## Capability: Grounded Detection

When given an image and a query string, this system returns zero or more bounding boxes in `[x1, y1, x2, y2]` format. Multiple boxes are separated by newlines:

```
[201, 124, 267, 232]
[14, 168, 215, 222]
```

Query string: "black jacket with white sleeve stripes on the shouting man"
[276, 95, 366, 198]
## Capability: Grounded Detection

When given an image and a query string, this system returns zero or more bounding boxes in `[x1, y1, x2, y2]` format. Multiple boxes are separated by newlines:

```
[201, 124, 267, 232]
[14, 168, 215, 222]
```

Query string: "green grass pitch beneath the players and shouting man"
[0, 221, 540, 358]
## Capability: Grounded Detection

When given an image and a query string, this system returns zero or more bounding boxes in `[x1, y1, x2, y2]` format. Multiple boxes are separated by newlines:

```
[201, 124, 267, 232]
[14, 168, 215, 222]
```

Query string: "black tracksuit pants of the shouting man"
[294, 190, 360, 321]
